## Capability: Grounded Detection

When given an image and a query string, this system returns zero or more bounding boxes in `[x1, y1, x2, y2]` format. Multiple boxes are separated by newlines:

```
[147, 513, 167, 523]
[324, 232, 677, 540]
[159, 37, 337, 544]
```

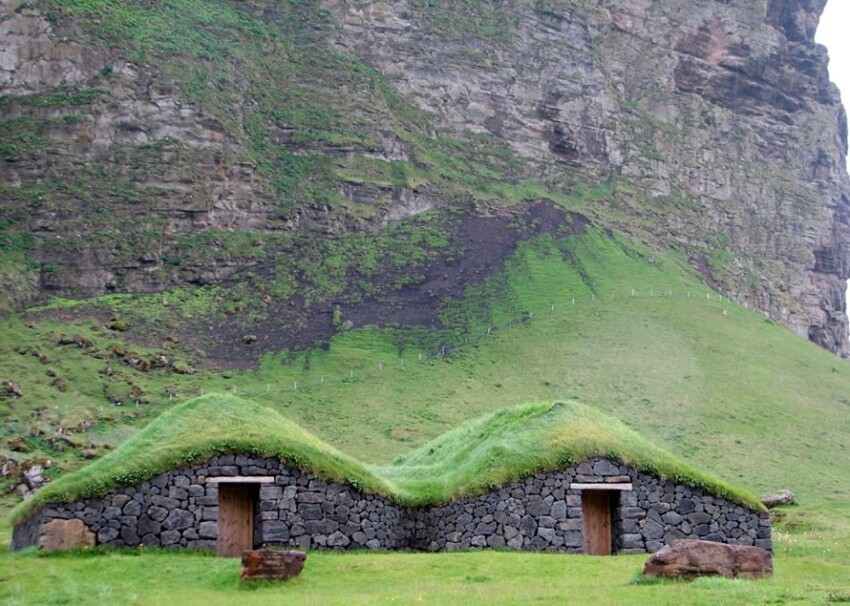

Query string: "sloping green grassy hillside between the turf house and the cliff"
[0, 232, 850, 508]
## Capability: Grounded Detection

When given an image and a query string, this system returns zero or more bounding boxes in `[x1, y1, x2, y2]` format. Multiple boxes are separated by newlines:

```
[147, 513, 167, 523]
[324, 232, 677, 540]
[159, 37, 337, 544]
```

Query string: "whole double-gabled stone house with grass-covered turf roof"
[12, 395, 771, 556]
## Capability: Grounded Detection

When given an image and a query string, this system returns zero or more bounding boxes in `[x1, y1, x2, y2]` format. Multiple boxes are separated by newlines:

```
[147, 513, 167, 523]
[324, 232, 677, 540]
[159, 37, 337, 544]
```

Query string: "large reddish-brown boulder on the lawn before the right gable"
[643, 540, 773, 579]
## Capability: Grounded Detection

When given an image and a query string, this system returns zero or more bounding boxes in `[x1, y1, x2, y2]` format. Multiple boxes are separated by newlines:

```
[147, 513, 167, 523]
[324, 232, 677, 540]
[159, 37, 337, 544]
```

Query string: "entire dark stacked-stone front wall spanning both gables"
[12, 455, 772, 553]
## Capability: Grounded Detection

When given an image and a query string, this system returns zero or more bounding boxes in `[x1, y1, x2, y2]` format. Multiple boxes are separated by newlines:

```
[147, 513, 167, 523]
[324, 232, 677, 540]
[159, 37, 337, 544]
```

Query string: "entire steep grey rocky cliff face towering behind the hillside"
[0, 0, 850, 353]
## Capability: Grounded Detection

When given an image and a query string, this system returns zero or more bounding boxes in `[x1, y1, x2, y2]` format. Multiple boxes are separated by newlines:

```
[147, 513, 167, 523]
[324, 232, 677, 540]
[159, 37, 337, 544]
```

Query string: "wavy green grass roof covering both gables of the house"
[12, 394, 762, 522]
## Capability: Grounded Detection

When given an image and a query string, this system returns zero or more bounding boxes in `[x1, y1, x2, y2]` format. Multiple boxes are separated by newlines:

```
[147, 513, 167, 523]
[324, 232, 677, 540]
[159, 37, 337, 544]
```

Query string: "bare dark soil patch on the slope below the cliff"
[195, 201, 589, 369]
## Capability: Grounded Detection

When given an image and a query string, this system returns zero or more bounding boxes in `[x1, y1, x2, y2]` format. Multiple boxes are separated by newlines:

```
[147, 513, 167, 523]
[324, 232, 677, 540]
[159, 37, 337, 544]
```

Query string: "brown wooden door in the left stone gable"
[215, 484, 257, 558]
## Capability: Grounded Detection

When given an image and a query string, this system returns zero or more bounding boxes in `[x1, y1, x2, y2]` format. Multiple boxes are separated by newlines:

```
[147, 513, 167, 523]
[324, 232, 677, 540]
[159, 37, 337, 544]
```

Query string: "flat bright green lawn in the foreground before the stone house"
[0, 503, 850, 606]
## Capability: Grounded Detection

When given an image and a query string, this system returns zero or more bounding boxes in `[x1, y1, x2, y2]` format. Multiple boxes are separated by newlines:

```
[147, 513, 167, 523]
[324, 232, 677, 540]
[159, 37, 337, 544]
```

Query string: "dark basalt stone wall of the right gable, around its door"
[404, 458, 772, 553]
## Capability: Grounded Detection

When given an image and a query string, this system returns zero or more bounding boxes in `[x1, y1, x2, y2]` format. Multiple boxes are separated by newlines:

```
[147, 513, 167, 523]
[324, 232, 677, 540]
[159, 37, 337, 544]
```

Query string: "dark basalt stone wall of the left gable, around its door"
[12, 455, 403, 549]
